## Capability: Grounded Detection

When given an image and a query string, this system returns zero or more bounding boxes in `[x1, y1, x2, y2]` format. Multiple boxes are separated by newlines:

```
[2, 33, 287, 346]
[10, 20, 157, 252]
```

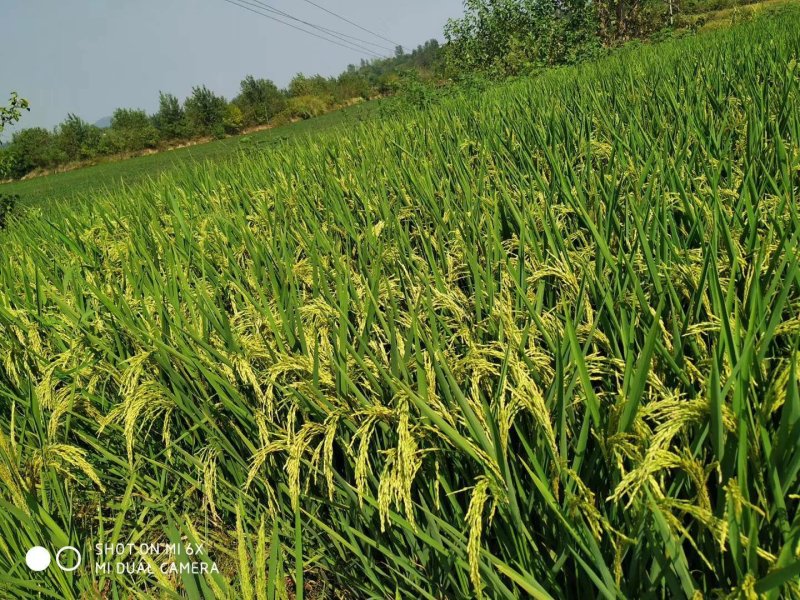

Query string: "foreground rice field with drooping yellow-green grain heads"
[0, 8, 800, 600]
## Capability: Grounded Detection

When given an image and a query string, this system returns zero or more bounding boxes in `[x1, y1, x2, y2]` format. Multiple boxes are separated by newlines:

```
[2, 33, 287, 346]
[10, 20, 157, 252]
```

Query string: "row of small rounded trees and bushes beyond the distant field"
[0, 40, 443, 179]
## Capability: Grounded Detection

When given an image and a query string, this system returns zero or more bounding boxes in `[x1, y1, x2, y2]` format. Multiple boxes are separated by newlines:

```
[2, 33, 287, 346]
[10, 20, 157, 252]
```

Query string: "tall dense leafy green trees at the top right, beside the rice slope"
[444, 0, 753, 78]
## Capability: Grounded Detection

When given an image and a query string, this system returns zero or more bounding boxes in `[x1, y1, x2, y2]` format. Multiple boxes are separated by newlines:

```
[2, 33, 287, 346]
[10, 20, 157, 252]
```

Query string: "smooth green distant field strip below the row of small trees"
[0, 100, 382, 206]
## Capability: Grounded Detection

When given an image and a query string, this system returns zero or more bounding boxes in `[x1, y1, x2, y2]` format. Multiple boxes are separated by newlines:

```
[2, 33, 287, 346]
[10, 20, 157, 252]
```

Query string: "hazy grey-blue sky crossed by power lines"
[0, 0, 462, 139]
